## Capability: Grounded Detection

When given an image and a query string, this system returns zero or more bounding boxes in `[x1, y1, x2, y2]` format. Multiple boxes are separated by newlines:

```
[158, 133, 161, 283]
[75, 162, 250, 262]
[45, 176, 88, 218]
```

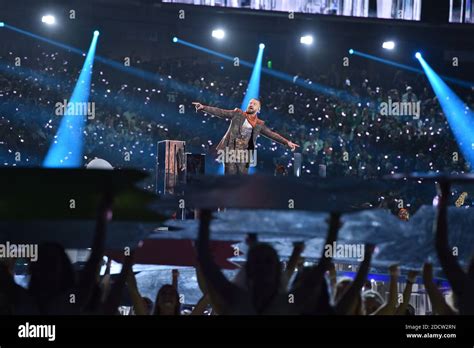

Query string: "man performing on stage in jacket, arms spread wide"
[193, 99, 299, 174]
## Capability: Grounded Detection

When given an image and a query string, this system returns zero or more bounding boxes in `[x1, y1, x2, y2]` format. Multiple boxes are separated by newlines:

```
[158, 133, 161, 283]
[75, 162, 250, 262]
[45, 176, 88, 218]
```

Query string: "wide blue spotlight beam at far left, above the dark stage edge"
[43, 33, 99, 168]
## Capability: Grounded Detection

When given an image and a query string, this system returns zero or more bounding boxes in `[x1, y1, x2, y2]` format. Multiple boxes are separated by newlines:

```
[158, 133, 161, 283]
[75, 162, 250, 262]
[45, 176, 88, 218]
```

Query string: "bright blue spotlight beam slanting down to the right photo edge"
[418, 55, 474, 171]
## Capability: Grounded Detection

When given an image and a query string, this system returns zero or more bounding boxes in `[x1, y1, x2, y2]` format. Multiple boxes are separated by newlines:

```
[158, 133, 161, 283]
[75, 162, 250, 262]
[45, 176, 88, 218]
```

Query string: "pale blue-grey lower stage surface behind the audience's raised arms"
[158, 206, 474, 270]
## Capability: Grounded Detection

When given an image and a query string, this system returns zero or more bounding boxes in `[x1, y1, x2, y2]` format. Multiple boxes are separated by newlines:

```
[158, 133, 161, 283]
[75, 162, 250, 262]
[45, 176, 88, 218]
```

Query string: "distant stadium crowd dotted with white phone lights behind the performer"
[0, 45, 474, 203]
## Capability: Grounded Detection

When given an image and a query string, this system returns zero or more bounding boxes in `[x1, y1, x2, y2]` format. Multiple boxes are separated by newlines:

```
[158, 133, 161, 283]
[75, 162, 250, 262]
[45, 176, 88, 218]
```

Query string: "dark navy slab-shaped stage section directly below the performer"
[183, 175, 389, 212]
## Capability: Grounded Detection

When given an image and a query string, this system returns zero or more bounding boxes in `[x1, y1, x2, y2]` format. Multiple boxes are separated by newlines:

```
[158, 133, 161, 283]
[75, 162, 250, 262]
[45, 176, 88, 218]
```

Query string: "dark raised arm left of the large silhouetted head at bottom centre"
[196, 210, 244, 314]
